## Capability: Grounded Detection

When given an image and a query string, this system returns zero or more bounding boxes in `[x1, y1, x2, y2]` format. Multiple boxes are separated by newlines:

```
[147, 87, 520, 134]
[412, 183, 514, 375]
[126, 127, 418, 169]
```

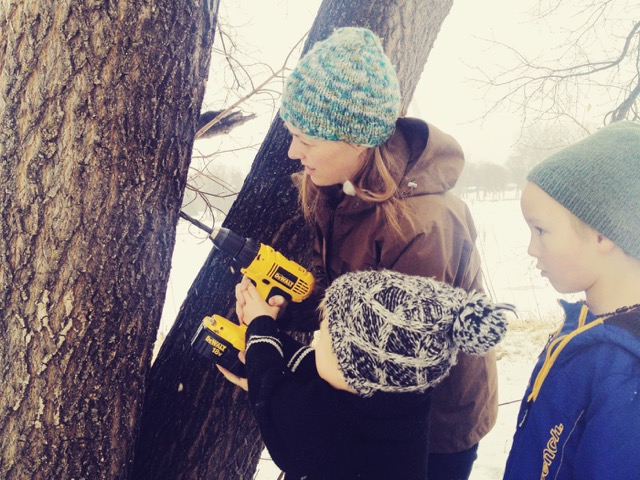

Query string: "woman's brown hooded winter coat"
[288, 118, 498, 453]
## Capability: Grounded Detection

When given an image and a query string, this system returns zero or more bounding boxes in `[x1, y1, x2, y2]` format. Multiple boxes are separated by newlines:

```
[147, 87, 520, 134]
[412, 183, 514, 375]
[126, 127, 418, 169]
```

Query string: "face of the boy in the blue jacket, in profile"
[520, 182, 598, 293]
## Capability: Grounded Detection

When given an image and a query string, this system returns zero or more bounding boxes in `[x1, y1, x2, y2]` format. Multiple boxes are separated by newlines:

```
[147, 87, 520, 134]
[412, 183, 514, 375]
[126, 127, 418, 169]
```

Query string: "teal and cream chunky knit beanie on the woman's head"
[280, 27, 400, 147]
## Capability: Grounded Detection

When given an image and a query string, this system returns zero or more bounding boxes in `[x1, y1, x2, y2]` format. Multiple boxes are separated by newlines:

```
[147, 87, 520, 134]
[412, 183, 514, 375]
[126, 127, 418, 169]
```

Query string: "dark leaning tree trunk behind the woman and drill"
[132, 0, 452, 480]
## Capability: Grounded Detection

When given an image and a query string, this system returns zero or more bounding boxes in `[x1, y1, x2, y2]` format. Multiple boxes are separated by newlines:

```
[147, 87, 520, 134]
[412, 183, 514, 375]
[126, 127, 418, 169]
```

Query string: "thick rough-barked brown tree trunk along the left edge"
[0, 0, 217, 480]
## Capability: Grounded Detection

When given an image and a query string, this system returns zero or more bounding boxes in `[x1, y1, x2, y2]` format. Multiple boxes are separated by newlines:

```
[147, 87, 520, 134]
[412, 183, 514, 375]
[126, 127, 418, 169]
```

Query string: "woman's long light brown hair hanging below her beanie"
[299, 144, 413, 236]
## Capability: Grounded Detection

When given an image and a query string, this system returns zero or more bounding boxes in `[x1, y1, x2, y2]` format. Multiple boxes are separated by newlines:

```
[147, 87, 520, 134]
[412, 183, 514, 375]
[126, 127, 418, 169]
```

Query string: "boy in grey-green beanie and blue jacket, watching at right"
[504, 122, 640, 480]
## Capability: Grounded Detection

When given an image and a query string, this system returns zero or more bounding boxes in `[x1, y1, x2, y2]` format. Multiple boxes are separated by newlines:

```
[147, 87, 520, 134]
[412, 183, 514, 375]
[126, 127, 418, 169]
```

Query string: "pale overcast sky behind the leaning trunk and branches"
[196, 0, 604, 172]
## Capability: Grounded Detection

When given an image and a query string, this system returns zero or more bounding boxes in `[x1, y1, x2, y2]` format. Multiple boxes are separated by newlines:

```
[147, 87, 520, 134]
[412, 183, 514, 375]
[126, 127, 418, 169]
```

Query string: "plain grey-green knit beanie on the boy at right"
[527, 122, 640, 259]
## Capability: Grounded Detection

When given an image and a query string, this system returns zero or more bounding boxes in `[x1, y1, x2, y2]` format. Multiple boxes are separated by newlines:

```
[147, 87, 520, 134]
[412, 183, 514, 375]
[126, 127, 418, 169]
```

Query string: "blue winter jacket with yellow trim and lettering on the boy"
[504, 302, 640, 480]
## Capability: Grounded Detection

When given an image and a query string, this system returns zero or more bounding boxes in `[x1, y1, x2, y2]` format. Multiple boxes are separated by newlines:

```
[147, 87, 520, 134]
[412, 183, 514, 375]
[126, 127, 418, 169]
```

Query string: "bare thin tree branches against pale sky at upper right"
[480, 0, 640, 129]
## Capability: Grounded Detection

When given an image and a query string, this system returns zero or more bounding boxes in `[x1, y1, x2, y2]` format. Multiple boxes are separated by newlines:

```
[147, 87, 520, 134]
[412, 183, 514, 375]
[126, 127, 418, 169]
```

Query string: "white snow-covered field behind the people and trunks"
[161, 199, 576, 480]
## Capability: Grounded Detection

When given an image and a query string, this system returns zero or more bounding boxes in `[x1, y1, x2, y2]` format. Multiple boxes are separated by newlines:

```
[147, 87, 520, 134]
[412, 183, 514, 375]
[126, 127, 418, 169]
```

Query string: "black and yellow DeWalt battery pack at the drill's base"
[191, 315, 247, 377]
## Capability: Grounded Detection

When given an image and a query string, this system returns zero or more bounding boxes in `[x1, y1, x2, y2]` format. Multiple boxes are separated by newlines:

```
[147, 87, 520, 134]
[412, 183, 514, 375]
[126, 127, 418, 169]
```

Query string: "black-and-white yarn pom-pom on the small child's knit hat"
[452, 292, 514, 355]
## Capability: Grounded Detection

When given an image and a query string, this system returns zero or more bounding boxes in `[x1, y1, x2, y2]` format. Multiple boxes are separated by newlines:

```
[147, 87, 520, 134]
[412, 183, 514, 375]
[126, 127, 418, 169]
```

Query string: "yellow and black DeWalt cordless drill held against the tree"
[184, 216, 314, 377]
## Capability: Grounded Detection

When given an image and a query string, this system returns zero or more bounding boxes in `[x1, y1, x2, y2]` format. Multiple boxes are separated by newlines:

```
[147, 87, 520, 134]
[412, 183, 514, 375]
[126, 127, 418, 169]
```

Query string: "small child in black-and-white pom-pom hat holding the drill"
[218, 270, 509, 480]
